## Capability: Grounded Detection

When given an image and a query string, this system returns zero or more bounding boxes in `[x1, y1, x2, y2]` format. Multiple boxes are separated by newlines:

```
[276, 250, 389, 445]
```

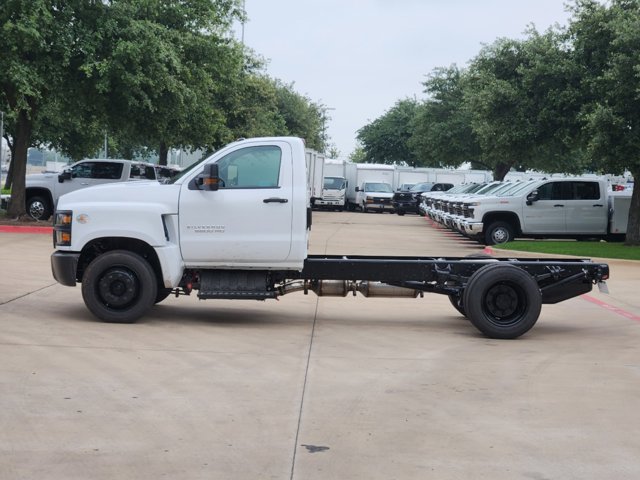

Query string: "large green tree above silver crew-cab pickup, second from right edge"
[465, 29, 581, 180]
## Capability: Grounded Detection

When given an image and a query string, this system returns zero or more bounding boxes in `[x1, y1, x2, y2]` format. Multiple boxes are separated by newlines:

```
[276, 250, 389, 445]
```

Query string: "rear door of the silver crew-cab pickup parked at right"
[566, 180, 609, 235]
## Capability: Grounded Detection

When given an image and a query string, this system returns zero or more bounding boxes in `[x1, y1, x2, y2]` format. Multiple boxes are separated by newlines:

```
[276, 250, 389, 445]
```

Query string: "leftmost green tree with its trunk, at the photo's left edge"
[0, 0, 106, 217]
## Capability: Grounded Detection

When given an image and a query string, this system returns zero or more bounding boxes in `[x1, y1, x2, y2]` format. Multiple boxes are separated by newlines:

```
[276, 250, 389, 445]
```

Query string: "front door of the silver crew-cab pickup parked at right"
[522, 182, 567, 233]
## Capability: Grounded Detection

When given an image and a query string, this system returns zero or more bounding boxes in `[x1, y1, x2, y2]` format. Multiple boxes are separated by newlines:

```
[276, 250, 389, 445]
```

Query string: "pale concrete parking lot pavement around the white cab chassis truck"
[0, 212, 640, 480]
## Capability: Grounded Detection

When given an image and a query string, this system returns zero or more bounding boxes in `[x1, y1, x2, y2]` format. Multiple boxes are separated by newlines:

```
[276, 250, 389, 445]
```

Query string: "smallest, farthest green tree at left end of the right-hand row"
[357, 99, 419, 166]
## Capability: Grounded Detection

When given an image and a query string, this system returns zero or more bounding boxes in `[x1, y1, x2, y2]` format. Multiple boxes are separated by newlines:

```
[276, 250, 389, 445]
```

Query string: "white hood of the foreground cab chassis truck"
[57, 180, 181, 214]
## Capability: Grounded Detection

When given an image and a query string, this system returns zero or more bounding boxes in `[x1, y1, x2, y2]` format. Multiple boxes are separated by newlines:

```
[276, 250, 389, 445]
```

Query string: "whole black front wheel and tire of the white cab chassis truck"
[82, 250, 158, 323]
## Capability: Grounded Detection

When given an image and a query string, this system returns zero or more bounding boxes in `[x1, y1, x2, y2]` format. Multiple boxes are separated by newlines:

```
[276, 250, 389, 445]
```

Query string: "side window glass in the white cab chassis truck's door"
[218, 145, 282, 188]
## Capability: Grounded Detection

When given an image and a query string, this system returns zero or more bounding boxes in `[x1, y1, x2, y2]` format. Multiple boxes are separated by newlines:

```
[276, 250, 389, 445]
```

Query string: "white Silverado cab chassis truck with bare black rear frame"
[51, 137, 609, 339]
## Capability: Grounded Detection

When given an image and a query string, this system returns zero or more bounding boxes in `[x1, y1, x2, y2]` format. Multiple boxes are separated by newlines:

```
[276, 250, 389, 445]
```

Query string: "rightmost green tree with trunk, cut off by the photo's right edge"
[569, 0, 640, 245]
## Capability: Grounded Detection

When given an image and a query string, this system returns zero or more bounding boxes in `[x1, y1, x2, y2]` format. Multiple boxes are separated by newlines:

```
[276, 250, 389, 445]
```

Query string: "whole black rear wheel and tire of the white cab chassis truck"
[462, 263, 542, 339]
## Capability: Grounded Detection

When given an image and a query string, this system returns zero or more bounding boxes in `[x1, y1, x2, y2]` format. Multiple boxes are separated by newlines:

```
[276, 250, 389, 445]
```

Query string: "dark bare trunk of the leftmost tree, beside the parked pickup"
[7, 110, 33, 218]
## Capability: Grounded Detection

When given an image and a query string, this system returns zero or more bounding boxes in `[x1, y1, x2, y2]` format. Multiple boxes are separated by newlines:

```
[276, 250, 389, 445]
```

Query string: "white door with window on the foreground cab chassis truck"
[179, 142, 293, 266]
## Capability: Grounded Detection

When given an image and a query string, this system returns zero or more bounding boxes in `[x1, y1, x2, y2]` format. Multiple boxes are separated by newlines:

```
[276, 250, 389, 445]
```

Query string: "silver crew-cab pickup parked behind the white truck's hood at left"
[25, 159, 157, 220]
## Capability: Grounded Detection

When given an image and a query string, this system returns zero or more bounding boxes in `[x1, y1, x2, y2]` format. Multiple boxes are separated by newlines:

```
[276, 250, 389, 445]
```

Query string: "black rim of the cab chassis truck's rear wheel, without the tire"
[482, 283, 527, 327]
